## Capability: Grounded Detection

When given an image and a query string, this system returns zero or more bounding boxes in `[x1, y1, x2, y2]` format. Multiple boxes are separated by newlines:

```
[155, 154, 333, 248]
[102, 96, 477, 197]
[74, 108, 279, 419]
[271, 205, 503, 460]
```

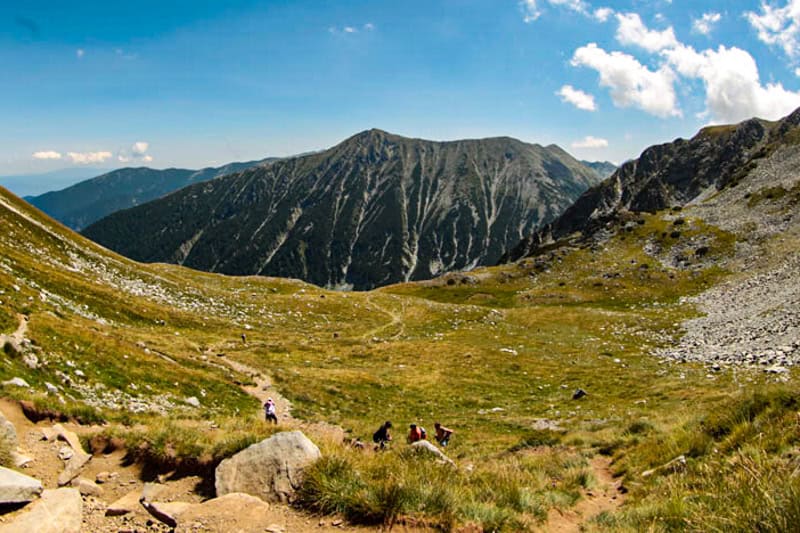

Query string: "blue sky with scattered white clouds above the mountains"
[0, 0, 800, 179]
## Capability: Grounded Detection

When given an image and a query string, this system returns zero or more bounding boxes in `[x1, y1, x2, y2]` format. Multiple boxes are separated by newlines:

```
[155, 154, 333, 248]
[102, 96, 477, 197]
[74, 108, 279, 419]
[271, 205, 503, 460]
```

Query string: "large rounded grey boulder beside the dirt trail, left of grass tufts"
[215, 431, 321, 503]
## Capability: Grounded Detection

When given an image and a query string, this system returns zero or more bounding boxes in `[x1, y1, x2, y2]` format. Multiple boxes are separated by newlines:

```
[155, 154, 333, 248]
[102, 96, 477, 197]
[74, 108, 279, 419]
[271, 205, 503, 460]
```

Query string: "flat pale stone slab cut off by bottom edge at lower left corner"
[0, 489, 83, 533]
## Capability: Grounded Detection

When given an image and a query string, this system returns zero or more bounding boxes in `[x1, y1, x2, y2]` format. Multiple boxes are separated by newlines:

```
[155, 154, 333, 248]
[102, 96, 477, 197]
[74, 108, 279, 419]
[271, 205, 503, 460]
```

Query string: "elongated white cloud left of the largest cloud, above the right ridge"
[572, 43, 681, 117]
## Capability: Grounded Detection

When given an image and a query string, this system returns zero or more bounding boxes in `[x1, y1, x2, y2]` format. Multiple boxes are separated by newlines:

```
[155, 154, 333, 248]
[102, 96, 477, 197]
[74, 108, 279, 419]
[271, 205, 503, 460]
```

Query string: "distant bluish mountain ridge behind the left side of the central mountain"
[26, 159, 269, 231]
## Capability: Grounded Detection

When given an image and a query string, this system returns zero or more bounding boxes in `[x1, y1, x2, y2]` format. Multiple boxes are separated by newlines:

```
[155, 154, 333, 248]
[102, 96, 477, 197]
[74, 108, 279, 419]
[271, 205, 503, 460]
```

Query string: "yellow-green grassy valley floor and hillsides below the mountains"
[0, 114, 800, 531]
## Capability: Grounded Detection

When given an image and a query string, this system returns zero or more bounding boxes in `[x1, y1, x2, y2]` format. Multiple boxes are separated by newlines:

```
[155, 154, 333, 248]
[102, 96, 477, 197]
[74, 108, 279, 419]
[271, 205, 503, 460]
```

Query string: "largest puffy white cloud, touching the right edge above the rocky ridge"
[662, 45, 800, 122]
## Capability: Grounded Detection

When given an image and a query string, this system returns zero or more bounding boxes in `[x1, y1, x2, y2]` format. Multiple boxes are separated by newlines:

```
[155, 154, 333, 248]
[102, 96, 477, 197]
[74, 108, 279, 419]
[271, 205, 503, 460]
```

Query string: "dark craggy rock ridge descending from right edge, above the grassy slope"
[503, 110, 800, 261]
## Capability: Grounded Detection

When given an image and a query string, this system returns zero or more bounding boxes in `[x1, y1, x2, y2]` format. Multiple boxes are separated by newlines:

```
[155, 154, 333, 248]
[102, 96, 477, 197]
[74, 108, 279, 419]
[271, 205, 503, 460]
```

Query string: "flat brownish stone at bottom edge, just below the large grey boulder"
[175, 492, 275, 533]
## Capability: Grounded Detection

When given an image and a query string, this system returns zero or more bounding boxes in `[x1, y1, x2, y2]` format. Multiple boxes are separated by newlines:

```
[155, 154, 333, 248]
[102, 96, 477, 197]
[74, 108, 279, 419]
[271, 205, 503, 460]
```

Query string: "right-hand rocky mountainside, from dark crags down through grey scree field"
[510, 106, 800, 368]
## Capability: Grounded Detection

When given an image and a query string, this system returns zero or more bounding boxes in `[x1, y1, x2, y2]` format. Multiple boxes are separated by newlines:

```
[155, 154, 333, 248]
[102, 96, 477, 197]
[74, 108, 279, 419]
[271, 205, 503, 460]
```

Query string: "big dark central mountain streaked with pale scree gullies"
[84, 130, 599, 289]
